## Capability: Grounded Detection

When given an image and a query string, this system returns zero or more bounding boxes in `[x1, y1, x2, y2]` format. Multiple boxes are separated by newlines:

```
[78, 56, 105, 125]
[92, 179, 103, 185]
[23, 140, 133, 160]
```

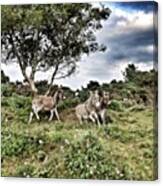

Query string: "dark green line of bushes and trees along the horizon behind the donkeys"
[1, 64, 157, 105]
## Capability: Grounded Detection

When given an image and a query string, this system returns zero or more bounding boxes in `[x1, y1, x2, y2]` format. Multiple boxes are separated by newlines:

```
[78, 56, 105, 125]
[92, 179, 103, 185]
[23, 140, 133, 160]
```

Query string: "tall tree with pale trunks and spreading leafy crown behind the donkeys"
[1, 3, 111, 94]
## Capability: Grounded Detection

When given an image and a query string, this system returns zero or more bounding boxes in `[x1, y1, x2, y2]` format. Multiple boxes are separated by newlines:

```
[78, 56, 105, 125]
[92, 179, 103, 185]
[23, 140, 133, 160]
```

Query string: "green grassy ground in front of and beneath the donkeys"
[1, 95, 155, 180]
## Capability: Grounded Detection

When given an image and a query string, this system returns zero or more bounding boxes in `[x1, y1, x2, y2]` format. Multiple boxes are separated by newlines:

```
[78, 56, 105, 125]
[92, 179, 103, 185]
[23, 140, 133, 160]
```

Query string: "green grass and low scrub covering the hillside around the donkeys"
[1, 66, 157, 180]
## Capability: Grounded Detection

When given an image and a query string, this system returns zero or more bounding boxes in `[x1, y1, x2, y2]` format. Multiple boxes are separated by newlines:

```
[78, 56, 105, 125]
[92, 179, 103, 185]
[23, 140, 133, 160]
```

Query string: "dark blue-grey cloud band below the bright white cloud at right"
[107, 28, 154, 62]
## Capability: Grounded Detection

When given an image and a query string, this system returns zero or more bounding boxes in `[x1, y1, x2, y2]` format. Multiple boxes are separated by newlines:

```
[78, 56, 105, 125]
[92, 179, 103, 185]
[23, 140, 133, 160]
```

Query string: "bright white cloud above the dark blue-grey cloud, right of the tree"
[97, 7, 154, 44]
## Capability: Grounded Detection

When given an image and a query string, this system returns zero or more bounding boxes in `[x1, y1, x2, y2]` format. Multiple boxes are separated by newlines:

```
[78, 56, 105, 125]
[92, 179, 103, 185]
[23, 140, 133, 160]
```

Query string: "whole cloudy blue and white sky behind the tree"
[1, 1, 157, 89]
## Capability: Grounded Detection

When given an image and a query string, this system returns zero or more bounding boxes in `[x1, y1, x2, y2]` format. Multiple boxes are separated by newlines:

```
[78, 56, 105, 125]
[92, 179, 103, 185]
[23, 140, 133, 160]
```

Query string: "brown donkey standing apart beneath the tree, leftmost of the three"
[28, 88, 64, 123]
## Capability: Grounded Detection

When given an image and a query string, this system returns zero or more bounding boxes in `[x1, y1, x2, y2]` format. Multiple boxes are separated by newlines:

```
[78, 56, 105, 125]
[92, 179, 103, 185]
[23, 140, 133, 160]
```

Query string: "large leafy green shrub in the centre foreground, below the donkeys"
[65, 134, 106, 179]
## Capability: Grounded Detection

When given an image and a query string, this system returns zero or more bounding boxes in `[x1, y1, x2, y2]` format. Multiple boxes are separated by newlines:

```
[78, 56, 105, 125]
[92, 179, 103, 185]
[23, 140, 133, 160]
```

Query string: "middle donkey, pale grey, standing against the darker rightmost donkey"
[75, 91, 100, 125]
